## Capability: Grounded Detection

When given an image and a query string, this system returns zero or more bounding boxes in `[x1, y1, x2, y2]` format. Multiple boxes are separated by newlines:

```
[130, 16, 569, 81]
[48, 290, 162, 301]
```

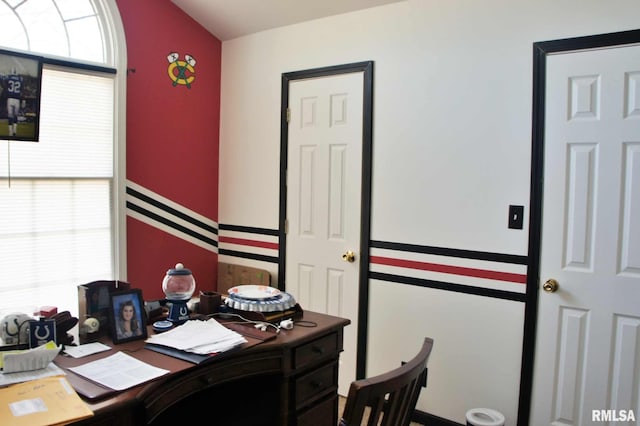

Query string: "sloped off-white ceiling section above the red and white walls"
[171, 0, 404, 41]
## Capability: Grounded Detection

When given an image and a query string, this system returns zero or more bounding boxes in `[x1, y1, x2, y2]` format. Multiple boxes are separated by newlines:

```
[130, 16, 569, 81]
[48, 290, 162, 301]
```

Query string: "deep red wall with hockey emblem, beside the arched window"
[117, 0, 222, 300]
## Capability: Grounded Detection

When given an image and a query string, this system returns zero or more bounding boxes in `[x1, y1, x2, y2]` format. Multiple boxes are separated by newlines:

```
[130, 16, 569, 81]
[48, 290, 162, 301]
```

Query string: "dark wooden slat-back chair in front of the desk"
[339, 337, 433, 426]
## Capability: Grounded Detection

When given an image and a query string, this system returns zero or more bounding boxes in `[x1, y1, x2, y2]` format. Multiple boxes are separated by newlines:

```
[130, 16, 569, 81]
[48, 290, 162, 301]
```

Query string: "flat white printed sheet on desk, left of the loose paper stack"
[69, 352, 169, 390]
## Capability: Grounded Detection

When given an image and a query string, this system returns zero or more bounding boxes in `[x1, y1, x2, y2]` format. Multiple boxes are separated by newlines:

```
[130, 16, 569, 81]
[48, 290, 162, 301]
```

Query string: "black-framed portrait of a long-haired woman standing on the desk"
[109, 289, 147, 344]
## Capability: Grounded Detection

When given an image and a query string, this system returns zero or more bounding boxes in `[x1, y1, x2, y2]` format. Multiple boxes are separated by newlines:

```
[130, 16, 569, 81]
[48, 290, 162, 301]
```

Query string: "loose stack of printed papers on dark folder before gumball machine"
[146, 318, 247, 355]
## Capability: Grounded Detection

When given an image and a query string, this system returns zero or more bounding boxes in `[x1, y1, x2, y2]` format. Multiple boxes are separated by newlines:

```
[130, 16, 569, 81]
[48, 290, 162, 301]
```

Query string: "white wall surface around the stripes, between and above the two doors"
[219, 0, 640, 424]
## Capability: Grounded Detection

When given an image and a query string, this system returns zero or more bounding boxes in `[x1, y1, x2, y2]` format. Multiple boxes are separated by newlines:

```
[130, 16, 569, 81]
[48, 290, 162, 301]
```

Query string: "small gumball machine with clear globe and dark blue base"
[162, 263, 196, 325]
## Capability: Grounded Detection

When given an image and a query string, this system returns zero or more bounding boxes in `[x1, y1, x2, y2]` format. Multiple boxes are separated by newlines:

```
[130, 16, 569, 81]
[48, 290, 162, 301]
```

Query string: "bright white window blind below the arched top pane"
[0, 65, 115, 317]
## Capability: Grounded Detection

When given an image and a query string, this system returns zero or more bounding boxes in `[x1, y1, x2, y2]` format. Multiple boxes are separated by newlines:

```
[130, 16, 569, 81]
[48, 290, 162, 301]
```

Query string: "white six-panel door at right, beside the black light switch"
[531, 46, 640, 425]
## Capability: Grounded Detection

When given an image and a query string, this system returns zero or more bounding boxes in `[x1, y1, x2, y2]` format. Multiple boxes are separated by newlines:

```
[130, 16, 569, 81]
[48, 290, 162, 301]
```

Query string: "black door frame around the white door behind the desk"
[278, 61, 373, 379]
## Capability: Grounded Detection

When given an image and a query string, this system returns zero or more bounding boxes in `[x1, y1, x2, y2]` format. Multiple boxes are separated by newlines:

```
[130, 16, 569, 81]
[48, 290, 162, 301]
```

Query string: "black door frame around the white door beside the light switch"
[518, 30, 640, 426]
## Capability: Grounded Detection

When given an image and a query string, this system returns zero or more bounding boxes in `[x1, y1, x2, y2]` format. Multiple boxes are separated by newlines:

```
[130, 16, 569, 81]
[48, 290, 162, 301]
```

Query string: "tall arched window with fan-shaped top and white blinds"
[0, 0, 126, 326]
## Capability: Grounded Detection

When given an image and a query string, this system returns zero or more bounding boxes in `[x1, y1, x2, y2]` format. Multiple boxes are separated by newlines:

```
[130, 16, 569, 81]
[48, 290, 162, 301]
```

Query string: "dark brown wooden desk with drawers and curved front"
[56, 312, 350, 426]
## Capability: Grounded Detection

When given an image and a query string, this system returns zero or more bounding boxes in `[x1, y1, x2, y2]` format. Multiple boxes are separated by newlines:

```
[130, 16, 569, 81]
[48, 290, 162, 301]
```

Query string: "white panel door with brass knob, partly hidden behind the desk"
[285, 72, 363, 395]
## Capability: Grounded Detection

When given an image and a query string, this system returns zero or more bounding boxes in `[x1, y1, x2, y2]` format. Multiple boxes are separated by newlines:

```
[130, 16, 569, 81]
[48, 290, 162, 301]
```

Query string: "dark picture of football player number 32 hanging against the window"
[0, 49, 43, 142]
